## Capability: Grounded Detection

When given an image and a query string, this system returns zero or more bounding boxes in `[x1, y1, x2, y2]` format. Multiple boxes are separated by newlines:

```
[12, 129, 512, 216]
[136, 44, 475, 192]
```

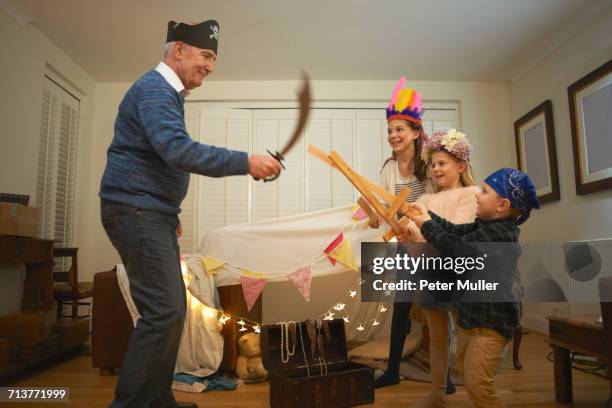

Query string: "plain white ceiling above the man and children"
[15, 0, 612, 82]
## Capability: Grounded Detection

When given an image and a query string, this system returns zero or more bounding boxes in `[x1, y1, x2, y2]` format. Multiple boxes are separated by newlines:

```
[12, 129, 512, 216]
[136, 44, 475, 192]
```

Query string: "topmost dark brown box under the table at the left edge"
[0, 309, 57, 343]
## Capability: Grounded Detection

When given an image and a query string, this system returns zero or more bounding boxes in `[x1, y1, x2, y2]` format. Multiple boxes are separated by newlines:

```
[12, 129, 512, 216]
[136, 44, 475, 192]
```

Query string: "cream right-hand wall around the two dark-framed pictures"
[510, 7, 612, 332]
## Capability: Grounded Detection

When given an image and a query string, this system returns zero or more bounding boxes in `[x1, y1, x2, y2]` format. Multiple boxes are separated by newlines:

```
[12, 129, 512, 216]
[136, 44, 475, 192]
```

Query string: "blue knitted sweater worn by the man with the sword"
[99, 71, 249, 214]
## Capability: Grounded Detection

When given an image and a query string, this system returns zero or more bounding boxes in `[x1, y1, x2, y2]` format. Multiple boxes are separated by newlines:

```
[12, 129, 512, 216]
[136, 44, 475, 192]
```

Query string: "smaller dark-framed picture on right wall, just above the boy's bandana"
[514, 100, 561, 203]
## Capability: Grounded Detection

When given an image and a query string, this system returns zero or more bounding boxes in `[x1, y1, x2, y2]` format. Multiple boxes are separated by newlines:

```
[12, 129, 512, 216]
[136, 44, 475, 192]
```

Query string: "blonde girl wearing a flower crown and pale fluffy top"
[407, 129, 480, 407]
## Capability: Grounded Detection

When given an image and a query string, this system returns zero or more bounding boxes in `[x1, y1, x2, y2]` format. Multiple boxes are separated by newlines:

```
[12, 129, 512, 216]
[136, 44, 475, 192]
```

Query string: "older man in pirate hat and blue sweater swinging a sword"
[99, 20, 281, 408]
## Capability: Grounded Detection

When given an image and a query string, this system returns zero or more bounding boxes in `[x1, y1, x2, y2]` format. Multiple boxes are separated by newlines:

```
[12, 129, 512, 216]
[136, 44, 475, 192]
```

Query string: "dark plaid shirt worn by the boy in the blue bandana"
[421, 211, 520, 339]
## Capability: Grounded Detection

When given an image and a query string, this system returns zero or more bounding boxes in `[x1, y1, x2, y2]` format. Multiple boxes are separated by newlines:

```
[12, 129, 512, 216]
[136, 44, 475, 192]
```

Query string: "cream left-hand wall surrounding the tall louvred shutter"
[0, 10, 94, 314]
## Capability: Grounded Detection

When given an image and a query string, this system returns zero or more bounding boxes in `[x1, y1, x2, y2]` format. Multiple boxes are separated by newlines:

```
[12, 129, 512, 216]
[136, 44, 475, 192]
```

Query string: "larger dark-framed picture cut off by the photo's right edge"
[567, 60, 612, 194]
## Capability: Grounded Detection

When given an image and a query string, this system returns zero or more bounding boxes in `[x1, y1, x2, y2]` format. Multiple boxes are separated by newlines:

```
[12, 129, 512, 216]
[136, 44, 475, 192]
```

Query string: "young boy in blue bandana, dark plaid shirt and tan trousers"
[412, 168, 540, 408]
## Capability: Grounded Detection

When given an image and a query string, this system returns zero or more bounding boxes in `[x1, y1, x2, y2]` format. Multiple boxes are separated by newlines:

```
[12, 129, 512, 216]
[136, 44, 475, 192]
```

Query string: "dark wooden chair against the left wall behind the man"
[53, 248, 93, 319]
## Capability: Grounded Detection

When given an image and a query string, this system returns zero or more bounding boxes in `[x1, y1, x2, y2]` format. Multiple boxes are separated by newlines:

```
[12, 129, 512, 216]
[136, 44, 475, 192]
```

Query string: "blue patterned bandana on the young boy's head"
[485, 167, 540, 225]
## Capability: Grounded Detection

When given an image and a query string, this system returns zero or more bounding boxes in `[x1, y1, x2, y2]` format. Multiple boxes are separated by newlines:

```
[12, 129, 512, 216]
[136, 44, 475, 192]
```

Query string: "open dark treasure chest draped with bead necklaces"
[261, 319, 374, 408]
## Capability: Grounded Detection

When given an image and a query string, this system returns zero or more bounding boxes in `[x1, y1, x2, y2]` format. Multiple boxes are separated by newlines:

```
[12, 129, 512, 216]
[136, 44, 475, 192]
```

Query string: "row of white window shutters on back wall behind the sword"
[175, 102, 457, 253]
